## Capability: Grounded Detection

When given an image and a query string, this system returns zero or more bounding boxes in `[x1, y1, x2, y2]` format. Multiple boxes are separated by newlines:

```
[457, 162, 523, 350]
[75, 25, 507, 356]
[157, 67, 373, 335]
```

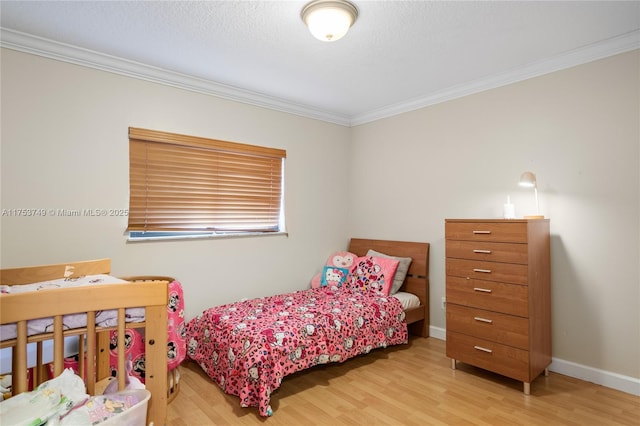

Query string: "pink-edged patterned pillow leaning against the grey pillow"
[347, 256, 400, 296]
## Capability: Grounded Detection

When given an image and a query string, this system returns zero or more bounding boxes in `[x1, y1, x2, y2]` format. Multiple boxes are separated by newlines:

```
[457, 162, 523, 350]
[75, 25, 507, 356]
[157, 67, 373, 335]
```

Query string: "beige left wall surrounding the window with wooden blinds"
[1, 49, 350, 318]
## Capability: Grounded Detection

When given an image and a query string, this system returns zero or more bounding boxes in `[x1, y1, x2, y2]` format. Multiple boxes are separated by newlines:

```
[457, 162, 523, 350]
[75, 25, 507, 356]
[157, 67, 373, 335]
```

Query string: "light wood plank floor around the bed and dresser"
[168, 337, 640, 426]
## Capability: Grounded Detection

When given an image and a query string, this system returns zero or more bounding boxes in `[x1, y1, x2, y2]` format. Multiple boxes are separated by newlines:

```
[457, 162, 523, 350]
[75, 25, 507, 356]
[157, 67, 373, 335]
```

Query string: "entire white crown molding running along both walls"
[0, 28, 640, 127]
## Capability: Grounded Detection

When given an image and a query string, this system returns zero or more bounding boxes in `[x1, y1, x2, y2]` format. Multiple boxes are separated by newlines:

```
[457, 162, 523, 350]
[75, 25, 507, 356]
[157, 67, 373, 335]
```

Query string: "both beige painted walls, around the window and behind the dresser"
[0, 49, 640, 386]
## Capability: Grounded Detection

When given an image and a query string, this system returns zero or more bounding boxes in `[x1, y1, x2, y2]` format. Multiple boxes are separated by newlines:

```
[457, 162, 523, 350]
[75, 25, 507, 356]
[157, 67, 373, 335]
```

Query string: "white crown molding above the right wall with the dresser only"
[350, 30, 640, 126]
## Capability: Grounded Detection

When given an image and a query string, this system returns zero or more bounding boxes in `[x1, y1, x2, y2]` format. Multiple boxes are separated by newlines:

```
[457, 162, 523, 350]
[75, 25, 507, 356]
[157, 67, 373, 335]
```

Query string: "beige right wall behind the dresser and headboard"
[349, 51, 640, 378]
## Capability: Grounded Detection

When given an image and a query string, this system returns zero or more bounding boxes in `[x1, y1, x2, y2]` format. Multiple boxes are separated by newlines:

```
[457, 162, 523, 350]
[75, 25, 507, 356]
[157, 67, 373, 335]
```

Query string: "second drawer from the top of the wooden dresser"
[446, 240, 528, 265]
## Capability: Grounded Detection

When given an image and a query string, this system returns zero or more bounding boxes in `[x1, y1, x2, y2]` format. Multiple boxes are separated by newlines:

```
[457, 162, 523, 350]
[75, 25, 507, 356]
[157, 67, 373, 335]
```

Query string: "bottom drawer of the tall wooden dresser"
[447, 329, 531, 382]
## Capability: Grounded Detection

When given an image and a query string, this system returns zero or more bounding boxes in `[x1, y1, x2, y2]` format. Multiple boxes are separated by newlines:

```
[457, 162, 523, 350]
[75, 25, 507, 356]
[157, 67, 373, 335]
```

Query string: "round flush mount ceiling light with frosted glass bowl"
[300, 0, 358, 41]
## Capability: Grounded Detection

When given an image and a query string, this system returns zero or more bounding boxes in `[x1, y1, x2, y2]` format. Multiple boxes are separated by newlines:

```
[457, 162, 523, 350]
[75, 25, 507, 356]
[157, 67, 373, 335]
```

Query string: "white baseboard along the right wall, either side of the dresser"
[429, 326, 640, 396]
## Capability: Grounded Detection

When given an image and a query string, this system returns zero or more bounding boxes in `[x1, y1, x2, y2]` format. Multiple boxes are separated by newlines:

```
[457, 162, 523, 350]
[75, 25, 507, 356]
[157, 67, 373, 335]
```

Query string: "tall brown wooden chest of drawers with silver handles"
[445, 219, 551, 394]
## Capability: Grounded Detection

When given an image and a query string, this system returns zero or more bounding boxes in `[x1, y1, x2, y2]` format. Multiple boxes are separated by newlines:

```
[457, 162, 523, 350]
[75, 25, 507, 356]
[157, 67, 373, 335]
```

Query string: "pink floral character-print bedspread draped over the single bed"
[187, 287, 408, 416]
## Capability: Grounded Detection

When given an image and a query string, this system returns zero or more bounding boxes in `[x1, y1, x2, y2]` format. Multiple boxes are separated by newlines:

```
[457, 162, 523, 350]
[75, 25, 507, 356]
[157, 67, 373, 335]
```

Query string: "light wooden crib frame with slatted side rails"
[0, 259, 169, 425]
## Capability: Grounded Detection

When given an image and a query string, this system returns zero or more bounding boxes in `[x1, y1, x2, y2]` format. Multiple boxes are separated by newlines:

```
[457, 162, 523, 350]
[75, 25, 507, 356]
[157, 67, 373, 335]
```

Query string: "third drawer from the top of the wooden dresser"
[447, 258, 528, 285]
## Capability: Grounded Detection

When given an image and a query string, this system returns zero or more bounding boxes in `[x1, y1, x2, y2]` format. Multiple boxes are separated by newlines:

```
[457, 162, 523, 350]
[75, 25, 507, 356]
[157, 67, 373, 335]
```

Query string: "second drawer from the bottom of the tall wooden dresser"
[447, 303, 529, 350]
